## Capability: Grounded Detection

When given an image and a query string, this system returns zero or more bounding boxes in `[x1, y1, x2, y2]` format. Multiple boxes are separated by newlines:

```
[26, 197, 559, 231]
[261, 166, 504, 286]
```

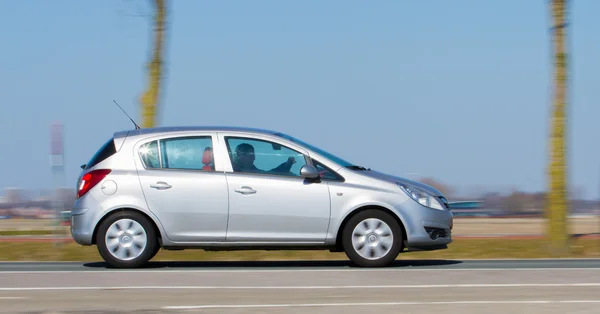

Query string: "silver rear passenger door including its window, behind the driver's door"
[136, 132, 229, 242]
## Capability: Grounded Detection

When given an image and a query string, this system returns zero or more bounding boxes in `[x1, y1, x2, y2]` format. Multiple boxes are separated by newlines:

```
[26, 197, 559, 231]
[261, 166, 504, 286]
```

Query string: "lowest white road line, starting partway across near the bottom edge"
[161, 300, 600, 310]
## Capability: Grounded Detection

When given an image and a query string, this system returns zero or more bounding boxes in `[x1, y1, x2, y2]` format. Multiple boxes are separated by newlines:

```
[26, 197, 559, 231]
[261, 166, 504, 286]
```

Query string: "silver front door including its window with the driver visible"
[223, 136, 330, 244]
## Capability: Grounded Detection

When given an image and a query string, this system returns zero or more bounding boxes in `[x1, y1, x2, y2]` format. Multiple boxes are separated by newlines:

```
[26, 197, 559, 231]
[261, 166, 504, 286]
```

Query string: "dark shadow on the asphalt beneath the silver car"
[83, 260, 462, 269]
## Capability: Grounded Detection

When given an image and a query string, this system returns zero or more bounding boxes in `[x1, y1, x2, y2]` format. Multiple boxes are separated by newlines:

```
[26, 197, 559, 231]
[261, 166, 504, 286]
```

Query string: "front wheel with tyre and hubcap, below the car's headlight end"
[342, 209, 403, 267]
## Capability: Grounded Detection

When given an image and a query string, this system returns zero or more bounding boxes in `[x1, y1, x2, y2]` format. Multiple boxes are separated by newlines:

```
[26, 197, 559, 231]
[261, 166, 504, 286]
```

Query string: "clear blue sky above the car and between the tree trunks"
[0, 0, 600, 198]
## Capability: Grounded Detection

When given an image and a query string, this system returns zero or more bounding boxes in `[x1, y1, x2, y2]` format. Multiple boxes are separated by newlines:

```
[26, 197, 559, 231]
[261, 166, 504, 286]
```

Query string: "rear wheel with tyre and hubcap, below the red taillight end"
[96, 211, 158, 268]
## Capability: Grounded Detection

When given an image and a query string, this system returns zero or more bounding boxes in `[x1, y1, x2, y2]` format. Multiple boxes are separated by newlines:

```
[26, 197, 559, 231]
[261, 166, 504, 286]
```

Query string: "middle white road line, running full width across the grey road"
[0, 282, 600, 291]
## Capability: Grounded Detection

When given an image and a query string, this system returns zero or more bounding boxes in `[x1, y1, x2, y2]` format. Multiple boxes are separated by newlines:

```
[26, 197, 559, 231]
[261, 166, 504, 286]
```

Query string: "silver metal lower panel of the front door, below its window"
[227, 173, 330, 243]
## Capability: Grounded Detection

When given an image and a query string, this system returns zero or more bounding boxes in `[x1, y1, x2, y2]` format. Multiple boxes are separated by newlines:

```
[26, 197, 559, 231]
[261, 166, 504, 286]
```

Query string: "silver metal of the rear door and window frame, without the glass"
[133, 132, 229, 244]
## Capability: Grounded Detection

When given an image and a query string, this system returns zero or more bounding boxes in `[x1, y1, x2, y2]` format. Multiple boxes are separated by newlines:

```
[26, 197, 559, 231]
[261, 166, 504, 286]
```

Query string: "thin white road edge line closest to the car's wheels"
[0, 266, 600, 275]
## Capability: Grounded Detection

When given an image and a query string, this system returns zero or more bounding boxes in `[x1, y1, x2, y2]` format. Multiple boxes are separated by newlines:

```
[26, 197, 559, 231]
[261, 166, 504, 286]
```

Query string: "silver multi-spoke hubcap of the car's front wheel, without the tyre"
[352, 218, 394, 260]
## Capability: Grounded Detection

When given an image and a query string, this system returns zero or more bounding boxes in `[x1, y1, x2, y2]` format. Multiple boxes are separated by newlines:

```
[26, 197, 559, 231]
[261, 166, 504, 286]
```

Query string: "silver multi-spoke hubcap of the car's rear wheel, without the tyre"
[104, 219, 148, 261]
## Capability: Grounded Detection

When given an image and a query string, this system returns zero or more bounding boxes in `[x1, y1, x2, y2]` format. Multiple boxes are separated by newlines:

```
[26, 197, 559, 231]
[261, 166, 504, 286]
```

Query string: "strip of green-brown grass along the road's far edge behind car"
[0, 238, 600, 262]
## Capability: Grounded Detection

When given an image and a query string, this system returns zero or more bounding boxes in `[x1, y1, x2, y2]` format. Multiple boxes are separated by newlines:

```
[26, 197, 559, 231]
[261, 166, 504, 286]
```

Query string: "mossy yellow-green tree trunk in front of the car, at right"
[547, 0, 568, 252]
